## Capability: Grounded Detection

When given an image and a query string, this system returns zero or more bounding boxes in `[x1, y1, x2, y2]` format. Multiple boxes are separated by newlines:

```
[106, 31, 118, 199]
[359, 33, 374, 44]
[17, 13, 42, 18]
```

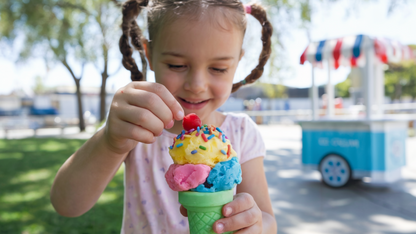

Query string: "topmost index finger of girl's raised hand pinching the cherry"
[131, 82, 184, 120]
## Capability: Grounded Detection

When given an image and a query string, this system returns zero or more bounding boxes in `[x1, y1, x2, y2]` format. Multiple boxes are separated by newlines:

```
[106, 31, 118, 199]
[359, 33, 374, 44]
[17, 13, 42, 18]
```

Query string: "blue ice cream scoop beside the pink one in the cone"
[192, 157, 242, 193]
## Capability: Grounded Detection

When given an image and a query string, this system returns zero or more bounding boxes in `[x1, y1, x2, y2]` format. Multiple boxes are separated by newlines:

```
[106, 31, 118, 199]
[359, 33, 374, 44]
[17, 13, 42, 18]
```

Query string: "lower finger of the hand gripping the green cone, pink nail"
[212, 208, 261, 233]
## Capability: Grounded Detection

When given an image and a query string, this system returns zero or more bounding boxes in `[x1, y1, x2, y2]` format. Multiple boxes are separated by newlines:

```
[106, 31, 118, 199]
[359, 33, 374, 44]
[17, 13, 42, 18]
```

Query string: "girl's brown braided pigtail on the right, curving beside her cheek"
[231, 3, 273, 92]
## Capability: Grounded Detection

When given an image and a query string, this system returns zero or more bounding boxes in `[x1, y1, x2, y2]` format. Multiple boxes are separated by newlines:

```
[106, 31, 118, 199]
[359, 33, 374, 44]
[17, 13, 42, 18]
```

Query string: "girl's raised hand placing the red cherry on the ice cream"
[104, 82, 184, 154]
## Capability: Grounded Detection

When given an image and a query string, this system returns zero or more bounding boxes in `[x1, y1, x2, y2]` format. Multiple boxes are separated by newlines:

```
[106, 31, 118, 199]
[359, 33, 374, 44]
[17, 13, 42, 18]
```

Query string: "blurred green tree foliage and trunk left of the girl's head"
[0, 0, 121, 131]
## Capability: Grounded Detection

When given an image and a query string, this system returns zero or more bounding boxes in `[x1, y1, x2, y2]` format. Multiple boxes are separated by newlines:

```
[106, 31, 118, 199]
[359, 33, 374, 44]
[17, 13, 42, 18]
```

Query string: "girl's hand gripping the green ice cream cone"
[180, 193, 263, 234]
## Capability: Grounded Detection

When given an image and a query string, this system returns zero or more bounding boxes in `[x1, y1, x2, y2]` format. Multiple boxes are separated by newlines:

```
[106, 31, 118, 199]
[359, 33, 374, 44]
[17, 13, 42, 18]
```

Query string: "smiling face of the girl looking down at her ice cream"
[147, 16, 243, 124]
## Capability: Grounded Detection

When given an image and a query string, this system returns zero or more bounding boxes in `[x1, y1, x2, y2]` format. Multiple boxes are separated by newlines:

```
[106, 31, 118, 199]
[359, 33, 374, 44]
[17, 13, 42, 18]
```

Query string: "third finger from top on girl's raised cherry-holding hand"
[118, 105, 164, 136]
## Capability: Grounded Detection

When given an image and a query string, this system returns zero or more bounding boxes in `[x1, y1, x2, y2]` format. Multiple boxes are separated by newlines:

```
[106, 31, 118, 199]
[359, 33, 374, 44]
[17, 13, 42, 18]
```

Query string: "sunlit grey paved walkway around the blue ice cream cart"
[260, 125, 416, 234]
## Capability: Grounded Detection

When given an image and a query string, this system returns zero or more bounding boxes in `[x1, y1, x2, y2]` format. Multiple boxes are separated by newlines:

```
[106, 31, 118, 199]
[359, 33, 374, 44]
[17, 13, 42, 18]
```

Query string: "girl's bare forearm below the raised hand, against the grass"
[50, 129, 127, 217]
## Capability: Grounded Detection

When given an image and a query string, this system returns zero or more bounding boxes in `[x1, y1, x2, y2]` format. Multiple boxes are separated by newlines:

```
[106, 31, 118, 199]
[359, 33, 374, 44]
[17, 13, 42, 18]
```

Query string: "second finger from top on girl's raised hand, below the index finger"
[127, 89, 173, 128]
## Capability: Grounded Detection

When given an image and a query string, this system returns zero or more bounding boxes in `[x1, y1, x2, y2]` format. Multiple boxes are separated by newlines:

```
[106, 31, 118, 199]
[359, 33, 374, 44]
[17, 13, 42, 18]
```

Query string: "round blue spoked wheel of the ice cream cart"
[319, 154, 351, 188]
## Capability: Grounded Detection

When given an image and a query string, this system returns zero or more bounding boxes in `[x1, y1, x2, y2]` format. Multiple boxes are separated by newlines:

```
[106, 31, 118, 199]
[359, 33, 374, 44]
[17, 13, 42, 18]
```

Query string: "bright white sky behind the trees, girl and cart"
[0, 0, 416, 94]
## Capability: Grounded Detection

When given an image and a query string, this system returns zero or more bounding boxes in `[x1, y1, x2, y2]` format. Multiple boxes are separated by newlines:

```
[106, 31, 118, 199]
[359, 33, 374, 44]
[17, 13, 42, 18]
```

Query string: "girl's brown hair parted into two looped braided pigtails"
[119, 0, 273, 92]
